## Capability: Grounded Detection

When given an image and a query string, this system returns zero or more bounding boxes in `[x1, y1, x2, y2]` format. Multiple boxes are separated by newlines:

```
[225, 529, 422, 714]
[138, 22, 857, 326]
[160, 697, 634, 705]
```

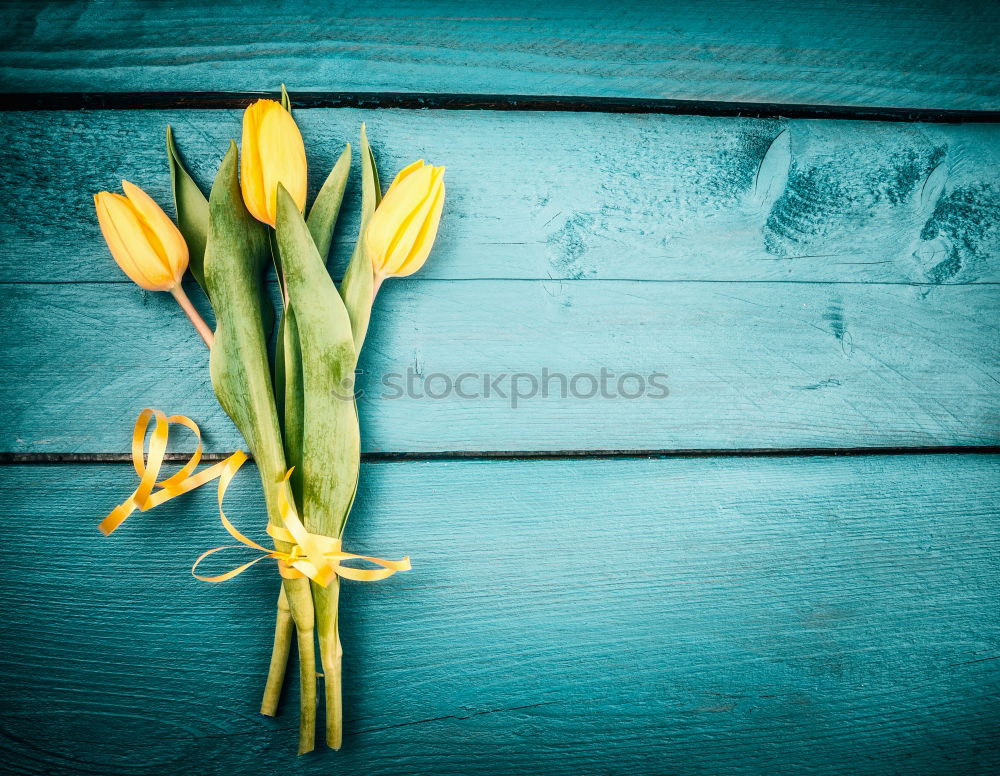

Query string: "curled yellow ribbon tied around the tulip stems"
[98, 409, 411, 587]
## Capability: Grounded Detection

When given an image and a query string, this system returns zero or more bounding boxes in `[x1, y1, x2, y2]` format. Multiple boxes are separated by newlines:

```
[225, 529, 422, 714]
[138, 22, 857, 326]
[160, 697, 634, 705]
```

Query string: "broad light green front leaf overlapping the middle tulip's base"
[275, 185, 361, 538]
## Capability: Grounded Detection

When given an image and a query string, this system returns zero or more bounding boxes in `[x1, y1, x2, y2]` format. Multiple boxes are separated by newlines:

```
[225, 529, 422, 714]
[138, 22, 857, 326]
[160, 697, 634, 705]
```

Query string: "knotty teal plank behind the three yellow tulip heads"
[0, 110, 1000, 284]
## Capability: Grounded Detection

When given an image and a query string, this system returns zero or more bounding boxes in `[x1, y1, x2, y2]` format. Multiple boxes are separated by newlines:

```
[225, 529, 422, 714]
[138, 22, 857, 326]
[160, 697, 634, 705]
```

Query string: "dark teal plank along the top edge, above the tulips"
[0, 0, 1000, 110]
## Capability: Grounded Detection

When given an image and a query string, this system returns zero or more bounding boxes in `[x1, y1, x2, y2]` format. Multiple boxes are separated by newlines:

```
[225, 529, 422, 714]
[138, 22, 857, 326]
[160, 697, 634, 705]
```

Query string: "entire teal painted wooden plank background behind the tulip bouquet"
[0, 0, 1000, 776]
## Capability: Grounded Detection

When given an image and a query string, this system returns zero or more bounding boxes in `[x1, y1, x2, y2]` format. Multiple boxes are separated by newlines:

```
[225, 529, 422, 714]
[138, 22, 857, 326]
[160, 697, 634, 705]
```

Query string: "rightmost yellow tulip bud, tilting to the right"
[365, 159, 444, 286]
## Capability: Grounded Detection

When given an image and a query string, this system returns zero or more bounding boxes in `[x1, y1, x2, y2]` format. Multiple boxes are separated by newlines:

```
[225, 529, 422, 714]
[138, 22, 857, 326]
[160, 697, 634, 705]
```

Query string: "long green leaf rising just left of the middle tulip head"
[205, 143, 285, 522]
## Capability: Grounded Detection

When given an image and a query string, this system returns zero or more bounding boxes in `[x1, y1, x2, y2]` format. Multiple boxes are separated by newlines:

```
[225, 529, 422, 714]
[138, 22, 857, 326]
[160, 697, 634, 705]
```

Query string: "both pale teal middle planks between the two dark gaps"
[0, 110, 1000, 453]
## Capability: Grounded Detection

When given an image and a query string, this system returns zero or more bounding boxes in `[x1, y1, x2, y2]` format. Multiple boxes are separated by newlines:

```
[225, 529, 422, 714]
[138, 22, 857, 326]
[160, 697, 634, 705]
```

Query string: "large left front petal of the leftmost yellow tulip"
[94, 191, 176, 291]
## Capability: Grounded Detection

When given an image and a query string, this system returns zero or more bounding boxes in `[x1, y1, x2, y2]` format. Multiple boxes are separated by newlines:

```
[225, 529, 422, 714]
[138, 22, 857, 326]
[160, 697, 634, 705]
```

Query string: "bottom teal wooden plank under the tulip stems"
[0, 455, 1000, 776]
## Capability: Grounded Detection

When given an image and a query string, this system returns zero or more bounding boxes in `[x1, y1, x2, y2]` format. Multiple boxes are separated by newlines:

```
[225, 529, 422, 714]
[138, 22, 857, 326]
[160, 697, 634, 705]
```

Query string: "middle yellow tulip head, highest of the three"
[240, 100, 306, 226]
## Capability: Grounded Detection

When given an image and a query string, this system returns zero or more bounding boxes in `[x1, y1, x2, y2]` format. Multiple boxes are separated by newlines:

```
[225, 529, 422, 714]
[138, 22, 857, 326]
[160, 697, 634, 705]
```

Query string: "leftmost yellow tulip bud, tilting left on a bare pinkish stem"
[94, 181, 188, 291]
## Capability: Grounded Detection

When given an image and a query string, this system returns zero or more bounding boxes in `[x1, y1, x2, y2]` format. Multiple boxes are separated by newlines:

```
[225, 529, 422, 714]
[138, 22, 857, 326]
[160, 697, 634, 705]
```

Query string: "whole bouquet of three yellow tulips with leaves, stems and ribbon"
[94, 87, 444, 754]
